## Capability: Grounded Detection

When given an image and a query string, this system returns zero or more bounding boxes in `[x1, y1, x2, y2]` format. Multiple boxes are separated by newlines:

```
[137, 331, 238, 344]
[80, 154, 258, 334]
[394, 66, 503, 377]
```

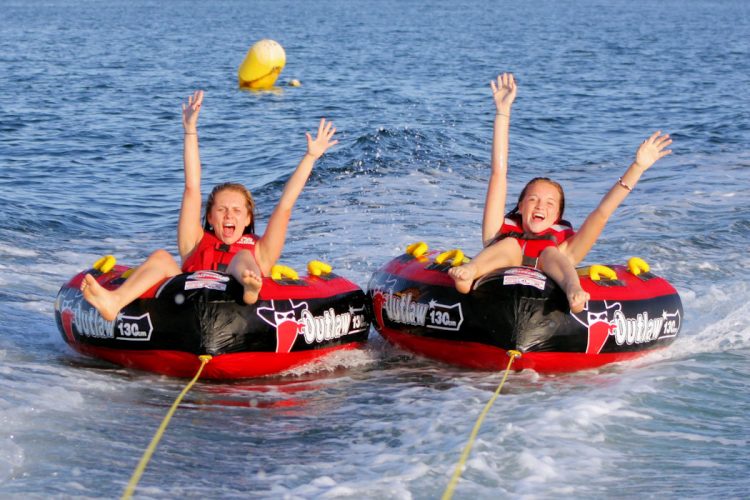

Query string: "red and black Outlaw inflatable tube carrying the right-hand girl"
[368, 244, 683, 372]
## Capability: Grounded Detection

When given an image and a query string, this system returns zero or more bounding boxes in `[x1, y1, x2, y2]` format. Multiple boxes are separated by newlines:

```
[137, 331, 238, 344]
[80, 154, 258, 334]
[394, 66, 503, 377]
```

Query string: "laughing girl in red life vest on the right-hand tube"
[449, 73, 672, 312]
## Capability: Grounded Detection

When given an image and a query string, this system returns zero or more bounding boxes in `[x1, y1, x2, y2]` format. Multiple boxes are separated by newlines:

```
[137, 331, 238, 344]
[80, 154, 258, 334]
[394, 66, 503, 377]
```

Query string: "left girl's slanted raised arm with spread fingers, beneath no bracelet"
[256, 118, 339, 275]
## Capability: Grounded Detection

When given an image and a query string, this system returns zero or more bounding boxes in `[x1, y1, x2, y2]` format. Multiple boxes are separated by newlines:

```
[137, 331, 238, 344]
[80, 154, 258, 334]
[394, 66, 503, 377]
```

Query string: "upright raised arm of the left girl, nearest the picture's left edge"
[177, 90, 203, 261]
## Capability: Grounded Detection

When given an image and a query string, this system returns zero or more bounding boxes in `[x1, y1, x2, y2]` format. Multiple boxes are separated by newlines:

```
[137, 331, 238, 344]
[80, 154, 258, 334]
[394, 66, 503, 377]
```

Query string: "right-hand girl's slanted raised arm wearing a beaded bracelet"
[560, 130, 672, 265]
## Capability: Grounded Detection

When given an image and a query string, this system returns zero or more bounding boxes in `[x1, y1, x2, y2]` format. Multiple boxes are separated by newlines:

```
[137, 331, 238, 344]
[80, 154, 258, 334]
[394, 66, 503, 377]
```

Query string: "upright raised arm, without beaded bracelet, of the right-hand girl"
[482, 73, 516, 245]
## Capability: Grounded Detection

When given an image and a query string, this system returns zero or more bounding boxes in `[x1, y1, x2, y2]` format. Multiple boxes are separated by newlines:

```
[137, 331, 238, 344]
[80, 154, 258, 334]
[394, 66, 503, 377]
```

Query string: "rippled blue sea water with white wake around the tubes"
[0, 0, 750, 499]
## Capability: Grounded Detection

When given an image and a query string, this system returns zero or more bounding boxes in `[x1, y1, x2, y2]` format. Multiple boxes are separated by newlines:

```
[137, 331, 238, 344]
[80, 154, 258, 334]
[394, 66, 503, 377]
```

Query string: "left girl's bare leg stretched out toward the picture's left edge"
[81, 250, 182, 321]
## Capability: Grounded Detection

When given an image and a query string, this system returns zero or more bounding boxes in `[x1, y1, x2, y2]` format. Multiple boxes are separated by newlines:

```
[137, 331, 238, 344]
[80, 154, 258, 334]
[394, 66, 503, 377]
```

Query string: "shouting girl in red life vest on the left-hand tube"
[81, 90, 338, 321]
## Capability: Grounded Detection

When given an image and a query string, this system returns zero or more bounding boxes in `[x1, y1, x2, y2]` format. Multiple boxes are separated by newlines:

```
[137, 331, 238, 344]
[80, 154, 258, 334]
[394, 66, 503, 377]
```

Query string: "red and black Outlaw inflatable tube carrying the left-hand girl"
[55, 263, 370, 379]
